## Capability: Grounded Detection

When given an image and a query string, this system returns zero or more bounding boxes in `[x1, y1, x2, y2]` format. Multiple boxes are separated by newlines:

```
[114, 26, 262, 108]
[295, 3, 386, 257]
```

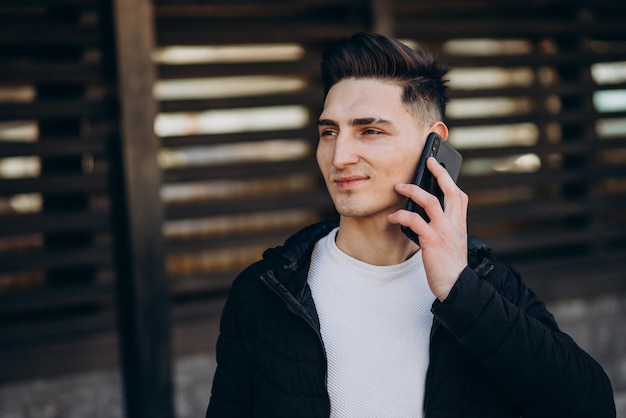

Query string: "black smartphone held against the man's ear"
[402, 132, 463, 245]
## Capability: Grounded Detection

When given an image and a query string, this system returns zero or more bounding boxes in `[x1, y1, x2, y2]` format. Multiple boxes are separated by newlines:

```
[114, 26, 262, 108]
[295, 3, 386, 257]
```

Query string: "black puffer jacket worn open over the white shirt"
[207, 223, 615, 418]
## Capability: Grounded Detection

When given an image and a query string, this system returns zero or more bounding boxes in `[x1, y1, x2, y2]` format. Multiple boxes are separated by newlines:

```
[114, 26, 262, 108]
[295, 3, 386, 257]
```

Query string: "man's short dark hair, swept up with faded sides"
[321, 32, 448, 123]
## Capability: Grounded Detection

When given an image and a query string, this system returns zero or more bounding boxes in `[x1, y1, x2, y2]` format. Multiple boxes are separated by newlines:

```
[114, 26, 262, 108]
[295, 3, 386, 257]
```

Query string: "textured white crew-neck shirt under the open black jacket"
[308, 229, 435, 418]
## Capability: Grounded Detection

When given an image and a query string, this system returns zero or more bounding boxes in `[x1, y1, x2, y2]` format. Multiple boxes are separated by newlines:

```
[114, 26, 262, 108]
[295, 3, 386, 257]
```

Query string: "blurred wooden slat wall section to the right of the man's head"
[393, 0, 626, 300]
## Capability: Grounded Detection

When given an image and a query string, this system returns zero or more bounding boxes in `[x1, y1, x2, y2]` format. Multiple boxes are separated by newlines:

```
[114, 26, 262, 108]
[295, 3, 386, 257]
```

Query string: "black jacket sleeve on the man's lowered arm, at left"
[206, 274, 253, 418]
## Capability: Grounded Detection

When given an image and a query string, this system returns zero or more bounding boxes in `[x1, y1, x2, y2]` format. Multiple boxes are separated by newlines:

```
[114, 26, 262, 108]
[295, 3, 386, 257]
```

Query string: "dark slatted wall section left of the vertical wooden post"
[0, 0, 118, 380]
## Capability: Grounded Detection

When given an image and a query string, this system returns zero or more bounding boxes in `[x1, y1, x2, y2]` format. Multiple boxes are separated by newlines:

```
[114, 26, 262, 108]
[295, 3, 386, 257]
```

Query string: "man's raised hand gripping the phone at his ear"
[389, 157, 468, 301]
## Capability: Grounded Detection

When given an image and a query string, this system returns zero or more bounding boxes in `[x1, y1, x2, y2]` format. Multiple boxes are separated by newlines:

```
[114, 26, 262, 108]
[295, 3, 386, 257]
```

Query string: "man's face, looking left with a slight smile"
[317, 78, 428, 218]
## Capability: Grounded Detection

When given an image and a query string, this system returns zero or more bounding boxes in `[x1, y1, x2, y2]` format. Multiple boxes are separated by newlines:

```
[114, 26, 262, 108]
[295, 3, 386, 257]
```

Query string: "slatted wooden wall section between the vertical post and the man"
[155, 0, 369, 305]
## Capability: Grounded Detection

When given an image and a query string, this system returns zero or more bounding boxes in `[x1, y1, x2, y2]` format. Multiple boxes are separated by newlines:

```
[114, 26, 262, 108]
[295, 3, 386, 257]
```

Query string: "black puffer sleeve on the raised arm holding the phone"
[433, 264, 616, 418]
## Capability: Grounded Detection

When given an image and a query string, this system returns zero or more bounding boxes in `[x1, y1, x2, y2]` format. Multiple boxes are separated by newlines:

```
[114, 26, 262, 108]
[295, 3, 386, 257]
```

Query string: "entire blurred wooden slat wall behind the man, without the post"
[0, 0, 626, 398]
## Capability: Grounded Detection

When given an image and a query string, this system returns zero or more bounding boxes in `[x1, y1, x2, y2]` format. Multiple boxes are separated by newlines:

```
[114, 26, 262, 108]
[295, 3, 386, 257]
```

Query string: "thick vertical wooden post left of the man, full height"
[112, 0, 174, 418]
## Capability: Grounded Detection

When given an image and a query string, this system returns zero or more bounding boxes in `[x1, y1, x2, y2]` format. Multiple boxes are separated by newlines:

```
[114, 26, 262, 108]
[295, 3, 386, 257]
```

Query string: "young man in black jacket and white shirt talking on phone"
[207, 33, 615, 418]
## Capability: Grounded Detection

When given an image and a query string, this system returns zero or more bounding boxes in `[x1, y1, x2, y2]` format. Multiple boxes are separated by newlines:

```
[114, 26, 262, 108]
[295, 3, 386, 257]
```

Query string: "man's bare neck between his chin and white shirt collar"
[336, 218, 419, 266]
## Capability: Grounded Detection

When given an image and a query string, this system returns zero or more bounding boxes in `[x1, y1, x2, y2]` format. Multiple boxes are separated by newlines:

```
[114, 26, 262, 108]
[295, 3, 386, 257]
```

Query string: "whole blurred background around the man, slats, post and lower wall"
[0, 0, 626, 418]
